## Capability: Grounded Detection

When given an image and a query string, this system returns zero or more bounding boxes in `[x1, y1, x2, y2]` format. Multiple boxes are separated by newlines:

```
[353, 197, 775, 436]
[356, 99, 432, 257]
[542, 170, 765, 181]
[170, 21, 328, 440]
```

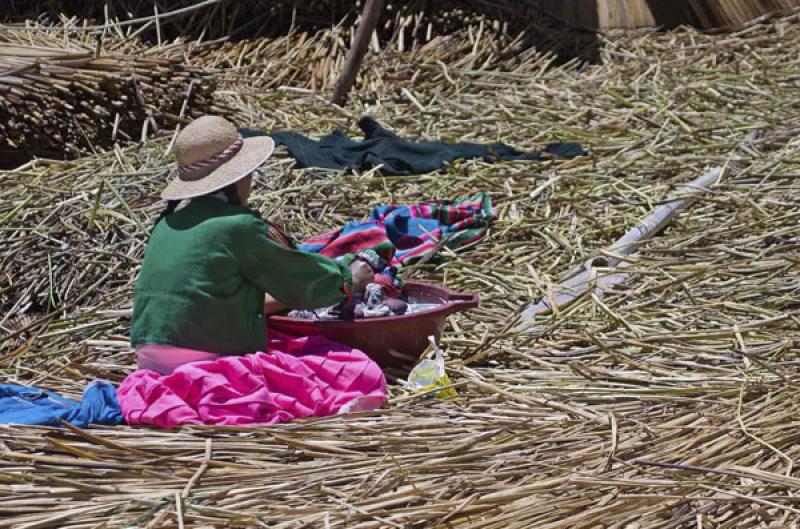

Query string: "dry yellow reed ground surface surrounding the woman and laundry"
[0, 8, 800, 529]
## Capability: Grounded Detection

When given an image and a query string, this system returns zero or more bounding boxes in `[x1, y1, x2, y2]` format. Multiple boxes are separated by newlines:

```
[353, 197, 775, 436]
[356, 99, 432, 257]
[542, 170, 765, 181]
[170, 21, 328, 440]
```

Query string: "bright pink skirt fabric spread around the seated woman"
[117, 331, 388, 428]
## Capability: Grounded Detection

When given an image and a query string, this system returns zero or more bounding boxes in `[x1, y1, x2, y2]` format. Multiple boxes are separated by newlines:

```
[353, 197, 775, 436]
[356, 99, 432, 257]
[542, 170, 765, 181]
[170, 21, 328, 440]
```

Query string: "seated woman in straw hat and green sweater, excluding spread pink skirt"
[131, 116, 373, 374]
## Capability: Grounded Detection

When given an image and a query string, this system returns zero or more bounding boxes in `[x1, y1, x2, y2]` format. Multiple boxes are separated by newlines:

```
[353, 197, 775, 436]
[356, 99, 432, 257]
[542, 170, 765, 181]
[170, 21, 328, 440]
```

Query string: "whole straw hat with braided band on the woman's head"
[161, 116, 275, 200]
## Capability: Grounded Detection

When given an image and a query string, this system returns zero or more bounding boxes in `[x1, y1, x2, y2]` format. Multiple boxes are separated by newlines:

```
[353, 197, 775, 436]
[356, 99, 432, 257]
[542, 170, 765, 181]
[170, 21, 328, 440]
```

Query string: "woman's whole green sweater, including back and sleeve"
[131, 197, 352, 354]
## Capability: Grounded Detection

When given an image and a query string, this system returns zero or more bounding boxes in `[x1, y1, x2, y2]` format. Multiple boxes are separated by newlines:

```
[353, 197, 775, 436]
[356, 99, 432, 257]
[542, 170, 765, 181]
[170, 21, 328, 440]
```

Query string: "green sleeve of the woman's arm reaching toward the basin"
[232, 212, 352, 309]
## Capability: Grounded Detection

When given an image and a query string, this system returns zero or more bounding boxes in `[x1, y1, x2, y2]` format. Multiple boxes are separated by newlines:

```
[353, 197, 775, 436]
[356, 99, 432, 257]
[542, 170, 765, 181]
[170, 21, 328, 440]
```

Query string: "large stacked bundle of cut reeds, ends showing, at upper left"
[0, 44, 219, 158]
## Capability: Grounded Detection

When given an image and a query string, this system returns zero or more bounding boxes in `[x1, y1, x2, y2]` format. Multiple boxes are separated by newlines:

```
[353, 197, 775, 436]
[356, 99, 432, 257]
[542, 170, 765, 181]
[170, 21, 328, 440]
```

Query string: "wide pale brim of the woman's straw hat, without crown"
[161, 136, 275, 200]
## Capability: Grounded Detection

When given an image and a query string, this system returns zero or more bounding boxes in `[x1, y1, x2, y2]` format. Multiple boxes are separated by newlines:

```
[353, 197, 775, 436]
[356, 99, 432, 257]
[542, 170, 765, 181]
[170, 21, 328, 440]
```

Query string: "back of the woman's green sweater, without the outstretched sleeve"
[131, 197, 266, 354]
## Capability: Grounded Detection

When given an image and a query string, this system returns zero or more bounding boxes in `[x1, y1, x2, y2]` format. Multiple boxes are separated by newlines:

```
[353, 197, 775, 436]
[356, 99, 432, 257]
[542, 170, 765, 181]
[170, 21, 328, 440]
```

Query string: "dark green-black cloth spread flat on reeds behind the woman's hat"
[239, 117, 586, 175]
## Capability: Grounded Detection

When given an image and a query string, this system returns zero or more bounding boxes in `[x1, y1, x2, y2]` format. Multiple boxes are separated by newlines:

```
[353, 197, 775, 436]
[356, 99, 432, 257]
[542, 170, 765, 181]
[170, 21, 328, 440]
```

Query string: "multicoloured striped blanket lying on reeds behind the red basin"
[300, 193, 495, 267]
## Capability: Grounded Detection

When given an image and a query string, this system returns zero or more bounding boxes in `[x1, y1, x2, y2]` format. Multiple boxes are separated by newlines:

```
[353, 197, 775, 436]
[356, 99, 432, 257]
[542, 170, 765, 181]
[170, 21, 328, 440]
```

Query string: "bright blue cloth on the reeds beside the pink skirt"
[0, 381, 125, 428]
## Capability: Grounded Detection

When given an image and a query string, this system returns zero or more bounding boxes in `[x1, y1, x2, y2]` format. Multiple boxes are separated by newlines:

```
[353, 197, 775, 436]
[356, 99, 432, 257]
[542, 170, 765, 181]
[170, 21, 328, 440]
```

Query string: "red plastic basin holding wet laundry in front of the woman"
[267, 281, 480, 371]
